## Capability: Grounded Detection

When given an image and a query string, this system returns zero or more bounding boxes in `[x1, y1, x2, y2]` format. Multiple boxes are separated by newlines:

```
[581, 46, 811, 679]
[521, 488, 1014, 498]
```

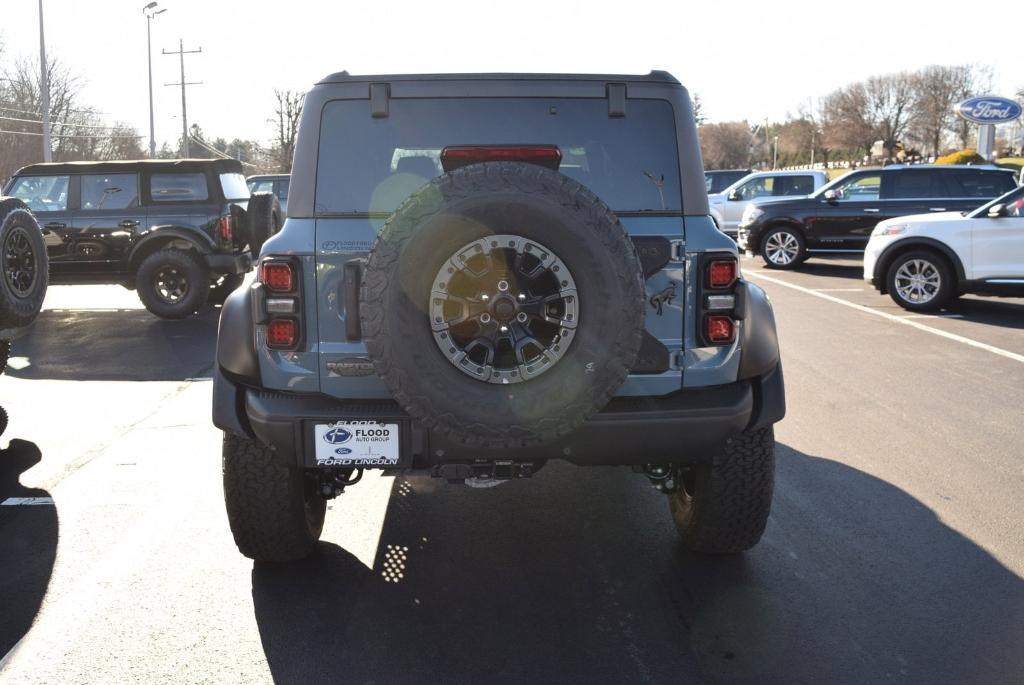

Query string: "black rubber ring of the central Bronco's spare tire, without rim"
[359, 162, 646, 447]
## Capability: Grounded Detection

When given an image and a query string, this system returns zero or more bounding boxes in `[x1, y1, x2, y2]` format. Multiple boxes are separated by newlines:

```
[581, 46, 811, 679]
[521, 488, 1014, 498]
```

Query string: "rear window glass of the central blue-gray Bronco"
[316, 98, 681, 213]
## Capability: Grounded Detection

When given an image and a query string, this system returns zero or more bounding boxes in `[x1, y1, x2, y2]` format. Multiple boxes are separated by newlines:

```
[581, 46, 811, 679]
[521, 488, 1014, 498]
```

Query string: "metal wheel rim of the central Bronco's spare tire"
[429, 234, 580, 384]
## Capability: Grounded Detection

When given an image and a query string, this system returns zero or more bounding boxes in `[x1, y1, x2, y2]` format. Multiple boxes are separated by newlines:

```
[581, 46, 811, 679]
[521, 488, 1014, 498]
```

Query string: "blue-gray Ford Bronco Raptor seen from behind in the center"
[213, 72, 785, 561]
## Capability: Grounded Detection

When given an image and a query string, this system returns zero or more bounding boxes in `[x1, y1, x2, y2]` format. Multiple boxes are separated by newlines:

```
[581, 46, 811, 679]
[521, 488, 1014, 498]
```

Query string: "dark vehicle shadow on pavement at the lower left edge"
[0, 439, 58, 659]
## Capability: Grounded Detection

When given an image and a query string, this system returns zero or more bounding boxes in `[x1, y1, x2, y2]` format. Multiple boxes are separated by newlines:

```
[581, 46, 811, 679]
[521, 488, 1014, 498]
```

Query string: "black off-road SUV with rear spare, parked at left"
[4, 160, 283, 318]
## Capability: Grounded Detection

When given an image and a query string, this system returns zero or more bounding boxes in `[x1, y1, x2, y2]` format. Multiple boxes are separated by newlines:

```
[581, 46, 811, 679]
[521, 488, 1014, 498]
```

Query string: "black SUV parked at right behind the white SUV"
[736, 165, 1016, 269]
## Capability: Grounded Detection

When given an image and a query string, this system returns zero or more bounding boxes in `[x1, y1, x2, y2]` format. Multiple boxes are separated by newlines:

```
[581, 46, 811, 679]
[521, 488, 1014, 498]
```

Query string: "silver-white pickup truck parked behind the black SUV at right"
[708, 170, 828, 238]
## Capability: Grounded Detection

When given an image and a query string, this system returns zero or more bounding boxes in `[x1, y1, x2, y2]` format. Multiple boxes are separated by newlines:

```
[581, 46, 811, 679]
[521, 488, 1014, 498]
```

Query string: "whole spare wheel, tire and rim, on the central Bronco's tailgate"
[359, 162, 644, 447]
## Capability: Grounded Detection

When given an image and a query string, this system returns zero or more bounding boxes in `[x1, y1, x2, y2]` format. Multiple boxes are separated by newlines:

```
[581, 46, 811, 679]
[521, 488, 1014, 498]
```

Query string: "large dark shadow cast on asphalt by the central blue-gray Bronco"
[252, 445, 1024, 683]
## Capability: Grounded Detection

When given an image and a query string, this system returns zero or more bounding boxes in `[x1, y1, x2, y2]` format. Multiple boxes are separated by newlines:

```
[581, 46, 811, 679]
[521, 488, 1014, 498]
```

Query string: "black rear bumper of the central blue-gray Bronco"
[213, 366, 785, 470]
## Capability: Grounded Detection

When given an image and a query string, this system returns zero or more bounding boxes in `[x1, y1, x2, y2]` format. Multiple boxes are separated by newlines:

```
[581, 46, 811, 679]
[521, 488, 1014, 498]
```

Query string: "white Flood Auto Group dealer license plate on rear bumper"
[313, 421, 399, 467]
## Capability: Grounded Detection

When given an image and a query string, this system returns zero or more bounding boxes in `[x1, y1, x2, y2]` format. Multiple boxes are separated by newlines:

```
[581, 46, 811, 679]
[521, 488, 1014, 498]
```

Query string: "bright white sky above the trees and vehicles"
[0, 0, 1024, 148]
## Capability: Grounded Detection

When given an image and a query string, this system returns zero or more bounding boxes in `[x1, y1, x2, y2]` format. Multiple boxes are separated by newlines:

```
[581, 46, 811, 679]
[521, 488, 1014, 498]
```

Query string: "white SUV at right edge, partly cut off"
[864, 181, 1024, 311]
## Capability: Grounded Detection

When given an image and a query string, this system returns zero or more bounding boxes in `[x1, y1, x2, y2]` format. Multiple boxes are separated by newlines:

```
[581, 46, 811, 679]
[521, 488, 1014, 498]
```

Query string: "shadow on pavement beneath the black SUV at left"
[6, 306, 220, 381]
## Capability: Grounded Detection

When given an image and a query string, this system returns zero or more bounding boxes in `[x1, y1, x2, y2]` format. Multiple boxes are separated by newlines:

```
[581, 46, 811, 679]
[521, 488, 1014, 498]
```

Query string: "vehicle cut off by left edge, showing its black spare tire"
[0, 197, 48, 433]
